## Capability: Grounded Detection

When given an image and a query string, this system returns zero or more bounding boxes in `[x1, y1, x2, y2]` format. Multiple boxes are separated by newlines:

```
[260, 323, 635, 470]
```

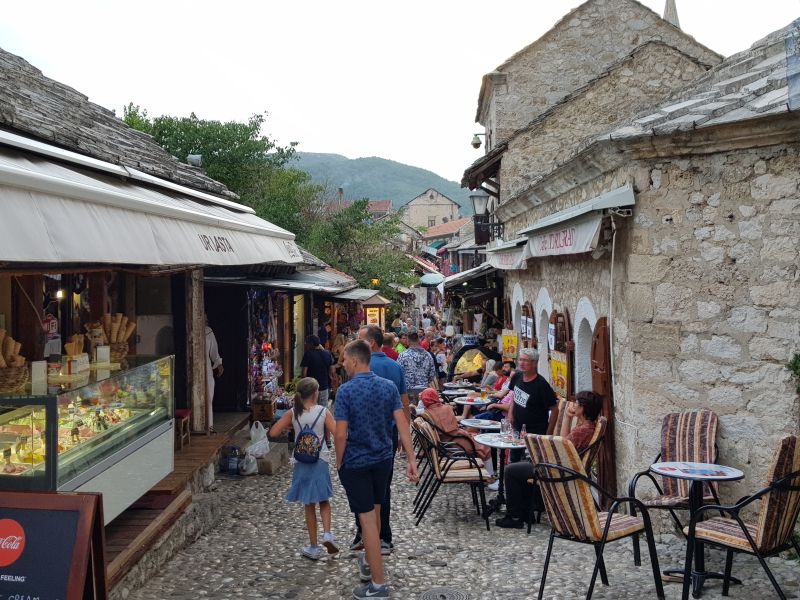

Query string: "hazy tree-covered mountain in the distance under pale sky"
[291, 152, 472, 215]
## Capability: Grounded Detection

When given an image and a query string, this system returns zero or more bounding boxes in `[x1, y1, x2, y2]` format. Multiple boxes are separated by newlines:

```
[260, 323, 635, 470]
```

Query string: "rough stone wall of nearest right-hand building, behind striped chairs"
[506, 144, 800, 500]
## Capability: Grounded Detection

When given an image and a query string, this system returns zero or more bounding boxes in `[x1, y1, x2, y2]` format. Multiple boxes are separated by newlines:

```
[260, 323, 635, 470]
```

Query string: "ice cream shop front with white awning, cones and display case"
[0, 137, 299, 522]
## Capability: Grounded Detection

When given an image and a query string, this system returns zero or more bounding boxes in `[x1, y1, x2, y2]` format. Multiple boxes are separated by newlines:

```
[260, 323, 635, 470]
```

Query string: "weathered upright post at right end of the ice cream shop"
[184, 269, 209, 433]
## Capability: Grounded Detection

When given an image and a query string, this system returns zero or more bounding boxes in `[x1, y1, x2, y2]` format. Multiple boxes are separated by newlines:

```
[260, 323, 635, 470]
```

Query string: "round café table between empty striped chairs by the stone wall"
[648, 462, 744, 600]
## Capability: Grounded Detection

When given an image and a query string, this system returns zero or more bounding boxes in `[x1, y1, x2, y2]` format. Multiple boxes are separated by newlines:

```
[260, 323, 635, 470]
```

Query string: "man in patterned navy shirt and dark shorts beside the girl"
[334, 340, 419, 599]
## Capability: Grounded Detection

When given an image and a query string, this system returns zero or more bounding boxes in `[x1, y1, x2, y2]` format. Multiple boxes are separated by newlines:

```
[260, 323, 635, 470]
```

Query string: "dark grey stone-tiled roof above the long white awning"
[0, 49, 236, 198]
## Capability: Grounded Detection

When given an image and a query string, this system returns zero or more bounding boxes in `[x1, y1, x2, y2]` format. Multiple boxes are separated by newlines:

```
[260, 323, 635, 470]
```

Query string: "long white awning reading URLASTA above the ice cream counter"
[0, 149, 302, 265]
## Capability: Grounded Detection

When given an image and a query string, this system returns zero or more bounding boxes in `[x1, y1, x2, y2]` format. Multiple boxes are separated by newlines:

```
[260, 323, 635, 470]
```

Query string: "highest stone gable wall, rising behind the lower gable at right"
[479, 0, 720, 145]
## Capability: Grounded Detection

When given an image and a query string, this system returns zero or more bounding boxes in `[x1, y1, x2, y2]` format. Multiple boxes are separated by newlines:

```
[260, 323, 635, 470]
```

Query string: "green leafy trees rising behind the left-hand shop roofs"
[123, 103, 415, 300]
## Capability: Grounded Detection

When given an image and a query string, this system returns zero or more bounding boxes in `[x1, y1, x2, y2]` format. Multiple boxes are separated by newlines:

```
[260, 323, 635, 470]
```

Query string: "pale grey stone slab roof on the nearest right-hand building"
[602, 25, 797, 139]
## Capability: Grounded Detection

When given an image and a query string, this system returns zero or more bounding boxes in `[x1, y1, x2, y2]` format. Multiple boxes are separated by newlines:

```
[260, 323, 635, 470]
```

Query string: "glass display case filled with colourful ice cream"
[0, 356, 174, 490]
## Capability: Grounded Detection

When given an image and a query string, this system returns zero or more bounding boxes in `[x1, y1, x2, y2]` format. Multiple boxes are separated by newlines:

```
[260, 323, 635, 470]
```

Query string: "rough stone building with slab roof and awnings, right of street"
[463, 0, 800, 499]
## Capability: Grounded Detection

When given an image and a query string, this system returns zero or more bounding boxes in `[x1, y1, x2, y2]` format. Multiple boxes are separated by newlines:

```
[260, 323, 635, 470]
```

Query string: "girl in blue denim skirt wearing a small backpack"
[270, 377, 339, 560]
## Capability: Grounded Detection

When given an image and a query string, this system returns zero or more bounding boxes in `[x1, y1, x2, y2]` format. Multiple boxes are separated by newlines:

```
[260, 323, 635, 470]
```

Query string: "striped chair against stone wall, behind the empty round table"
[628, 410, 719, 565]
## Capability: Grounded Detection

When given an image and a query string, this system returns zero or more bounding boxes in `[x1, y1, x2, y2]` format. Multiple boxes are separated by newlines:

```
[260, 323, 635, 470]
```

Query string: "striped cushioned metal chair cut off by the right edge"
[683, 436, 800, 600]
